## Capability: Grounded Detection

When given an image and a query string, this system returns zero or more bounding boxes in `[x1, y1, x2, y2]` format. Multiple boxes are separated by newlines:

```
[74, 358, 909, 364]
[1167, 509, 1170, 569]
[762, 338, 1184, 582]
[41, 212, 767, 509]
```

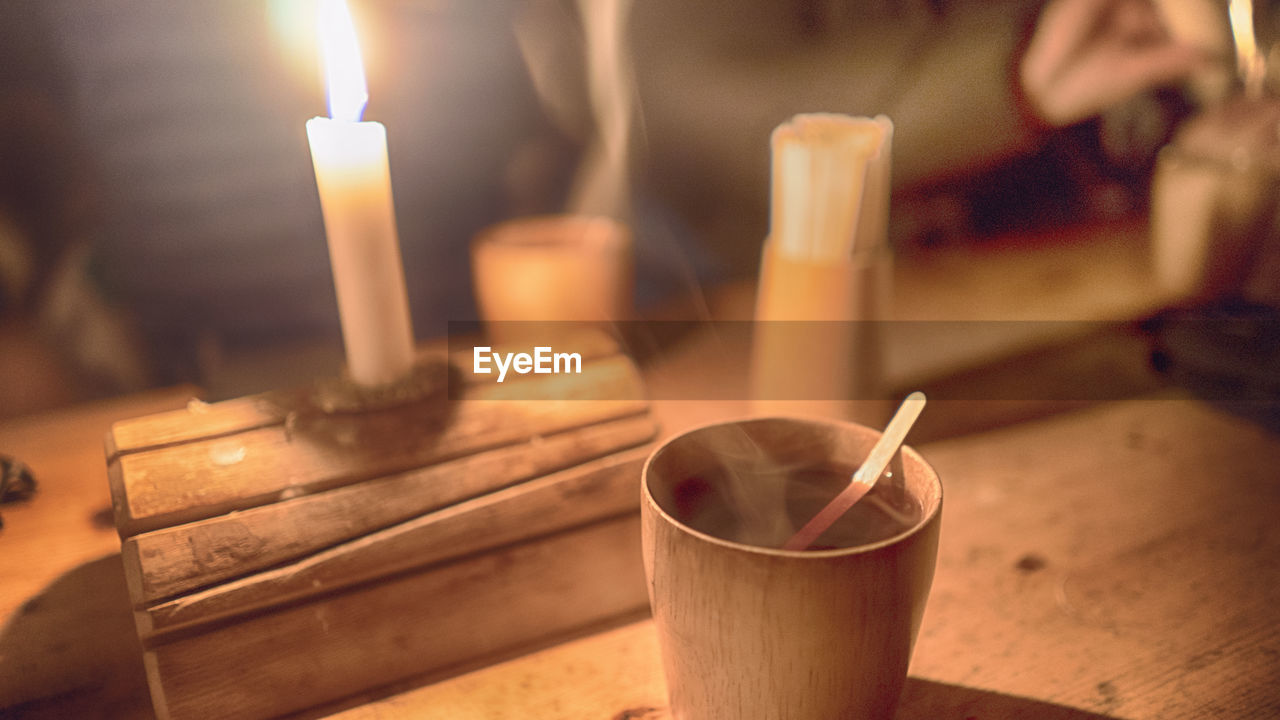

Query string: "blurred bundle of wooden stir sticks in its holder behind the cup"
[753, 113, 893, 423]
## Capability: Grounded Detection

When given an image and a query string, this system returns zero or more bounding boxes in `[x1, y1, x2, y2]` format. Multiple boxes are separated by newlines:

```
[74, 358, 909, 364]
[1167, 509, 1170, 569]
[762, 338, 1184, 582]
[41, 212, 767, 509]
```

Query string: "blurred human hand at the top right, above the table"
[1018, 0, 1208, 127]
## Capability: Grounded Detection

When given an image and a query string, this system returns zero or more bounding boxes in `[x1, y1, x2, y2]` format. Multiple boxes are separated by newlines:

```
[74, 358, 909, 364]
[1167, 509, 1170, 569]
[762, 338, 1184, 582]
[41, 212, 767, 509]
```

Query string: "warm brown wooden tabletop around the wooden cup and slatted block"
[0, 221, 1280, 720]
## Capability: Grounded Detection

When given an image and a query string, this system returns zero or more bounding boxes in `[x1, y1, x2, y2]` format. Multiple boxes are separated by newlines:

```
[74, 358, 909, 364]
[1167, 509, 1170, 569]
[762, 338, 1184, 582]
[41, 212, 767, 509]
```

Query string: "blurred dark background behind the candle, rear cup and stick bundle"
[0, 0, 1280, 416]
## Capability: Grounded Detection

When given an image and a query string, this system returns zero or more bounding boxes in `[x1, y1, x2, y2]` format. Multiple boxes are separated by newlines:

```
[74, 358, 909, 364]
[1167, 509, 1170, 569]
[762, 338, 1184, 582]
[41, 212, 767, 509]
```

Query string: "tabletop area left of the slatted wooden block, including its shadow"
[0, 387, 196, 717]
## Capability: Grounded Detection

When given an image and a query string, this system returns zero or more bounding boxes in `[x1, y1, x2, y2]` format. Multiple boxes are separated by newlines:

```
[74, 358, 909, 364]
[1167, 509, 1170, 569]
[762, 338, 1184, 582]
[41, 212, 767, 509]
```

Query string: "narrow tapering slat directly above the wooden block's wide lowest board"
[137, 448, 648, 642]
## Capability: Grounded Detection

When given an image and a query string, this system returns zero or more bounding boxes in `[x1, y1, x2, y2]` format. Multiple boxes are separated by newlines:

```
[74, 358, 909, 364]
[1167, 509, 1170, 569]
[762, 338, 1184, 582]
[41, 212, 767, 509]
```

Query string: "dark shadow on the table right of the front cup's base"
[896, 678, 1115, 720]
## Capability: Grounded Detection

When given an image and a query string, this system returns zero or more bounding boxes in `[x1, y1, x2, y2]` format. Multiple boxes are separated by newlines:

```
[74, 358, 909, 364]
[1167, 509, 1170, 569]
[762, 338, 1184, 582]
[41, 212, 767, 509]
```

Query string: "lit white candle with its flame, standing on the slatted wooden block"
[307, 0, 413, 386]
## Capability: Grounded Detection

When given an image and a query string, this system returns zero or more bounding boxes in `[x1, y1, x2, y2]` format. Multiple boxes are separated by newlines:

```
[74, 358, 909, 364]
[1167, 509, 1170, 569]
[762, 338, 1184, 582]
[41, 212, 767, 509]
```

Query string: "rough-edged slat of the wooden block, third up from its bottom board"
[122, 415, 657, 607]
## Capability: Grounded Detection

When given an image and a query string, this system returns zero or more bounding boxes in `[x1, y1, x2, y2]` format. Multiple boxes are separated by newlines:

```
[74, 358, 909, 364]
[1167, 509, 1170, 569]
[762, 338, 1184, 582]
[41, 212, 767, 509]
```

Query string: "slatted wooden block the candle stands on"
[106, 336, 657, 719]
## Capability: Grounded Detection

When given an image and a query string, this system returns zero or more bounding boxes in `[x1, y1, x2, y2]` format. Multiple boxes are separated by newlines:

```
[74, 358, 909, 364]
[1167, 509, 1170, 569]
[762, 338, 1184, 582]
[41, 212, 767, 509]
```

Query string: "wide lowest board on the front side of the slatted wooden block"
[146, 514, 645, 717]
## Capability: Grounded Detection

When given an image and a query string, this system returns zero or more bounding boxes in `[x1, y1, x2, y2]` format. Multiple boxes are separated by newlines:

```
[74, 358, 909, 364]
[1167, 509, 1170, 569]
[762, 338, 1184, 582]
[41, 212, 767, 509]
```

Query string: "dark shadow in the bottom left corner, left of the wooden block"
[0, 555, 155, 720]
